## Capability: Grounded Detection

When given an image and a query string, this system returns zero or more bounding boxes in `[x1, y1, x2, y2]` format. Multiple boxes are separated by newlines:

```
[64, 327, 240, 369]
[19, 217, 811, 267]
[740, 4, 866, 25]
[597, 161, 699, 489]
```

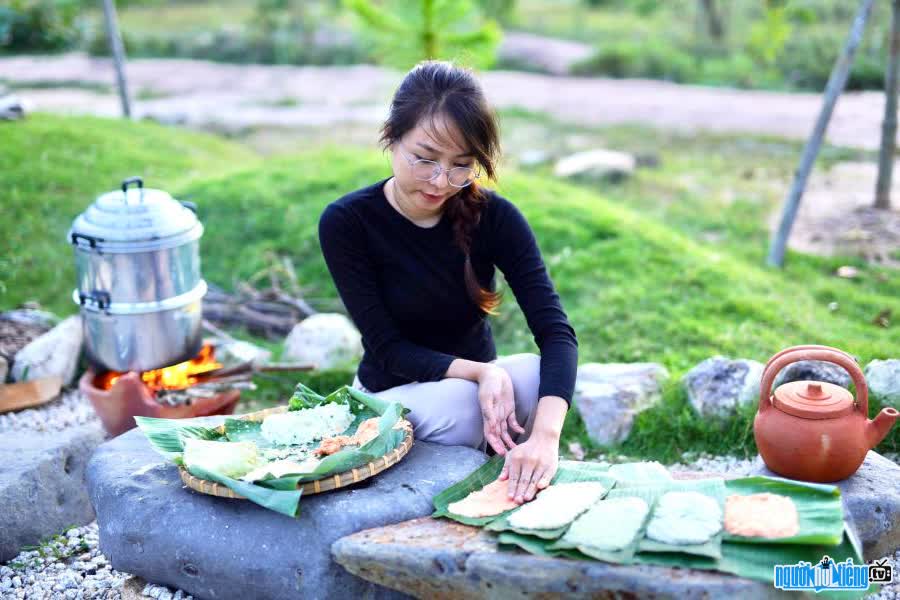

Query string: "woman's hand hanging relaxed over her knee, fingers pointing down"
[478, 363, 525, 456]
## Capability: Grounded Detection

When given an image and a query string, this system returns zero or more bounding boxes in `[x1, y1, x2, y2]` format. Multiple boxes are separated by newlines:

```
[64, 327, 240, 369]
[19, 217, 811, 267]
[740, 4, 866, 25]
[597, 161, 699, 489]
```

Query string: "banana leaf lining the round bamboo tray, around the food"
[136, 386, 408, 516]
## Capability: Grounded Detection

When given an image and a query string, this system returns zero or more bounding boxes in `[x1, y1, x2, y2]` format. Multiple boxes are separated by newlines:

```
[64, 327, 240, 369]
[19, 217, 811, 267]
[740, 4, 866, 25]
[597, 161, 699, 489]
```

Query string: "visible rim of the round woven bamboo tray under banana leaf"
[178, 406, 413, 500]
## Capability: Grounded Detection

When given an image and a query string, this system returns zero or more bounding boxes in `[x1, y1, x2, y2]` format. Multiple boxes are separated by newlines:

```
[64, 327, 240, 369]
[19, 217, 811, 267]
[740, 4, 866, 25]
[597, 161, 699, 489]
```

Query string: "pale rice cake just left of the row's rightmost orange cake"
[647, 492, 722, 546]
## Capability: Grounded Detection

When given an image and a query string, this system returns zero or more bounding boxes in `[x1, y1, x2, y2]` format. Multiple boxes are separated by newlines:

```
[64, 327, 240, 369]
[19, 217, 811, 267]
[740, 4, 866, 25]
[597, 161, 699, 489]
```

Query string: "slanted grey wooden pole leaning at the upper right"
[766, 0, 872, 267]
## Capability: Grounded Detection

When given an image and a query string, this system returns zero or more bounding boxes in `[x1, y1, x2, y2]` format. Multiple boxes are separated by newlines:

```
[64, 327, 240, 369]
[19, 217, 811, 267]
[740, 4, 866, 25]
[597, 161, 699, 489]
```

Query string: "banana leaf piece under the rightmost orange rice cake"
[724, 476, 844, 546]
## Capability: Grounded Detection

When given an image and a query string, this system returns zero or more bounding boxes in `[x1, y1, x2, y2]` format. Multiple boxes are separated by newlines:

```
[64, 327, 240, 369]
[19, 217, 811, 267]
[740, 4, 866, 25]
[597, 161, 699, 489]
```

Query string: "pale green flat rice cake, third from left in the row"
[562, 496, 650, 551]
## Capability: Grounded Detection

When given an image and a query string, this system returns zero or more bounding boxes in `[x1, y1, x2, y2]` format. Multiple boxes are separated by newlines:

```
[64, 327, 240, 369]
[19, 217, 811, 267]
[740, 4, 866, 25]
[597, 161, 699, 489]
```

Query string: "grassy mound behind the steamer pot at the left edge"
[0, 114, 257, 314]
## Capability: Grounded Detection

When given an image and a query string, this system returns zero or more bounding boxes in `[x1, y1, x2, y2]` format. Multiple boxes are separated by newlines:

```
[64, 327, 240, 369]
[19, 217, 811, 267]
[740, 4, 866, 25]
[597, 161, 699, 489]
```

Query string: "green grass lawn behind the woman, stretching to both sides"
[0, 113, 900, 461]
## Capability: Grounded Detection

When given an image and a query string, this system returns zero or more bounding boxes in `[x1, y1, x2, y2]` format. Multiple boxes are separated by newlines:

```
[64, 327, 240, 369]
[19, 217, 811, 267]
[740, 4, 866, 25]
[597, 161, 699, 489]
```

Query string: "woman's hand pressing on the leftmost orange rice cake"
[499, 431, 559, 504]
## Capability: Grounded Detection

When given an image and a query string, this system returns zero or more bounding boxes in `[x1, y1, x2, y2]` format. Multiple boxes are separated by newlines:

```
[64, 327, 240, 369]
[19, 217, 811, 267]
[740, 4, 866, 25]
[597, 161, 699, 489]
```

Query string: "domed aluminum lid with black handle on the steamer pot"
[69, 177, 202, 248]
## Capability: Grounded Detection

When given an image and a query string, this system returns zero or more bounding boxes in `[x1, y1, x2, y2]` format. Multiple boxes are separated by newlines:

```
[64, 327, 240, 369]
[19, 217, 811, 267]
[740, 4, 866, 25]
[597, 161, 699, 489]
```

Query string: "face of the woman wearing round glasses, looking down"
[391, 115, 475, 215]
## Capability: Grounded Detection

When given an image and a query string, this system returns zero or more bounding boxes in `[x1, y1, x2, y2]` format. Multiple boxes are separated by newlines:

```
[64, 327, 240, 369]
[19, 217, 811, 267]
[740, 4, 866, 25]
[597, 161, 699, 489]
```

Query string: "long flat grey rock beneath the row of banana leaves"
[331, 518, 783, 599]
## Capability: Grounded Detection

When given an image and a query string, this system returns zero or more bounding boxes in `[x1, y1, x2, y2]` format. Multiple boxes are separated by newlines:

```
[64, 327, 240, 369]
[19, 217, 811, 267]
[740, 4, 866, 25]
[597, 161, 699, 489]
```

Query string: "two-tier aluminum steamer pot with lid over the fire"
[68, 177, 206, 371]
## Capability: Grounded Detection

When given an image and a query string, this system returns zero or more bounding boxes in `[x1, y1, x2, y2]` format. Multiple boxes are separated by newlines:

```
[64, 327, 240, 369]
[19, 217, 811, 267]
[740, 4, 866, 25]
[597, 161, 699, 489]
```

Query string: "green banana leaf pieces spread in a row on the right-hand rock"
[433, 456, 862, 595]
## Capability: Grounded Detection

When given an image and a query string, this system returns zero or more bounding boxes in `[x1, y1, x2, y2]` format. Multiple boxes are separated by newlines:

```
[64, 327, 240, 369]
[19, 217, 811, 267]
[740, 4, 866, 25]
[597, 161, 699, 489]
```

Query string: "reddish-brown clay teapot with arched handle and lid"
[753, 346, 900, 483]
